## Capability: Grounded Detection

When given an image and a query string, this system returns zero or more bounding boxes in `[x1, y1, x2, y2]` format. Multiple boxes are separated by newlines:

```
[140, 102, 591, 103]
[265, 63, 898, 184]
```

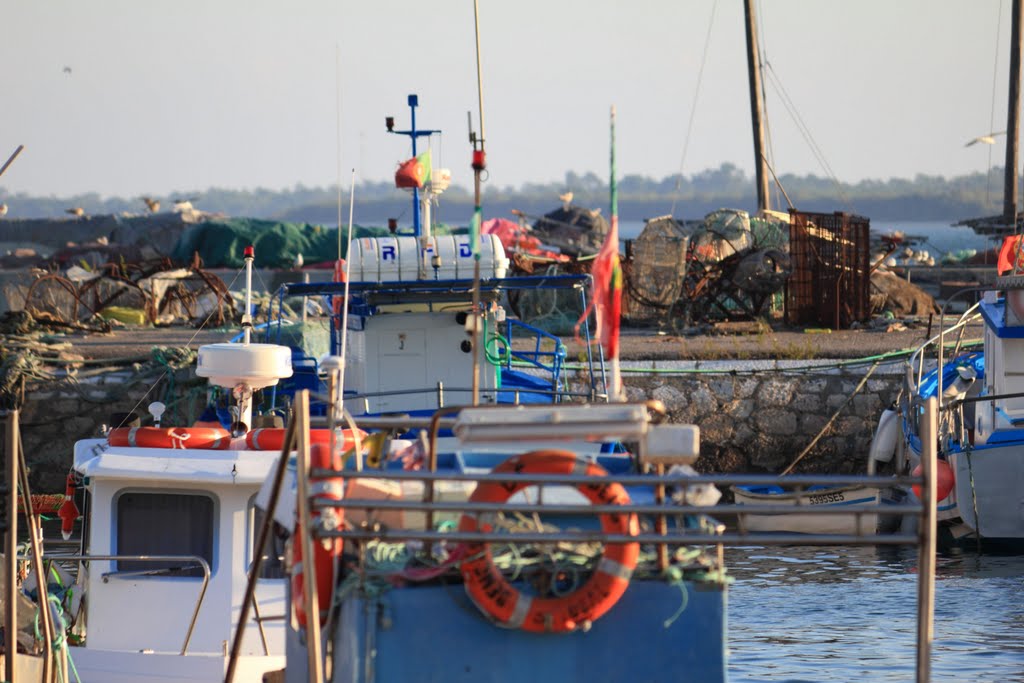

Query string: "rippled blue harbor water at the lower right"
[726, 547, 1024, 683]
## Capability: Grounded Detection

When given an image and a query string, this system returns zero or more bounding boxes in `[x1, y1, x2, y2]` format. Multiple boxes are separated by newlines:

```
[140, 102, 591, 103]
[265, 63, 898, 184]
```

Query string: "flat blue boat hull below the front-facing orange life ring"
[288, 581, 726, 683]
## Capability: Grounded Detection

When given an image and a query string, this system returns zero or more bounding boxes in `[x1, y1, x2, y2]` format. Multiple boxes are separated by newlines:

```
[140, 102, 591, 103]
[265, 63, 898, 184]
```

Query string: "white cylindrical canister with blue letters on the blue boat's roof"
[349, 234, 509, 283]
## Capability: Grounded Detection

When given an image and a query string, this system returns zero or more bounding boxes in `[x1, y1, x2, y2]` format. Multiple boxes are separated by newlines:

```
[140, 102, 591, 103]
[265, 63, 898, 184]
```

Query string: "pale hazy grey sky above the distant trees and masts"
[0, 0, 1010, 197]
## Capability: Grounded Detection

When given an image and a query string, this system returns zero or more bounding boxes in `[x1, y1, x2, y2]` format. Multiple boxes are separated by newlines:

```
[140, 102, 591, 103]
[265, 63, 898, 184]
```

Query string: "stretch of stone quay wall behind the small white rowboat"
[577, 360, 904, 474]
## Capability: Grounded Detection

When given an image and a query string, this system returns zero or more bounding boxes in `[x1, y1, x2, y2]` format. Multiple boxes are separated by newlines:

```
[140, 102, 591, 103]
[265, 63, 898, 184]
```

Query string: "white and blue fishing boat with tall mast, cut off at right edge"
[872, 0, 1024, 548]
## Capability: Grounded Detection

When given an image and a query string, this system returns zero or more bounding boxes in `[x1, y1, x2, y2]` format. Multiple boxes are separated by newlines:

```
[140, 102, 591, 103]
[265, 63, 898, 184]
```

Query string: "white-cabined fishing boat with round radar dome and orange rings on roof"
[18, 247, 339, 683]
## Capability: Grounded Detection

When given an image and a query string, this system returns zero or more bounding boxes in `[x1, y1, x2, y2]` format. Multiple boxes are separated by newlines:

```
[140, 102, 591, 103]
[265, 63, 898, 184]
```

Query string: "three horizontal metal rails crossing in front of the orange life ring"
[317, 468, 925, 547]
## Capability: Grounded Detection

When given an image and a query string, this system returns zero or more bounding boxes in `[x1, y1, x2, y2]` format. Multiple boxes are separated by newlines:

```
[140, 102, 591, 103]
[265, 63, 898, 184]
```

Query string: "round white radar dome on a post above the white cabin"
[196, 342, 292, 391]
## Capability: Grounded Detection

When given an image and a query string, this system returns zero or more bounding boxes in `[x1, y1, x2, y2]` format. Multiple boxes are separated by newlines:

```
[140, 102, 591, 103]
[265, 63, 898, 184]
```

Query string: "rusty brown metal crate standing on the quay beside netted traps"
[785, 210, 870, 330]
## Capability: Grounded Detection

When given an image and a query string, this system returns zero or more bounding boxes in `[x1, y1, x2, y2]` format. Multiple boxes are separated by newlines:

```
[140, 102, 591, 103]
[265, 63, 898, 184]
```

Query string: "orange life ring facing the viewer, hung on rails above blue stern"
[459, 451, 640, 633]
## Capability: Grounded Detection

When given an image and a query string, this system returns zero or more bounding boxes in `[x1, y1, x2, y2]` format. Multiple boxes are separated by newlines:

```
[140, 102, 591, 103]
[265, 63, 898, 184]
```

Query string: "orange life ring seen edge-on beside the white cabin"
[291, 443, 344, 628]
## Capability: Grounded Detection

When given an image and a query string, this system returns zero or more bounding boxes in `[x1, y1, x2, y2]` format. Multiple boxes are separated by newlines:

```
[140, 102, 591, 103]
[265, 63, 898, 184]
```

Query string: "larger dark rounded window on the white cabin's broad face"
[117, 492, 214, 577]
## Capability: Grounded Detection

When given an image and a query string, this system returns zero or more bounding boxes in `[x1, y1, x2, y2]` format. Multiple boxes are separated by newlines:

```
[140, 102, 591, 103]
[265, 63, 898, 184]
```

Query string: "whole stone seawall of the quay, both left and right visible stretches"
[22, 359, 903, 493]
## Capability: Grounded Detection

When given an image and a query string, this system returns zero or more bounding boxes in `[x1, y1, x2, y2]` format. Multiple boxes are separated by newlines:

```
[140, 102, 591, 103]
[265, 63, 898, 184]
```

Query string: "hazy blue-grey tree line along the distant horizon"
[0, 163, 1007, 225]
